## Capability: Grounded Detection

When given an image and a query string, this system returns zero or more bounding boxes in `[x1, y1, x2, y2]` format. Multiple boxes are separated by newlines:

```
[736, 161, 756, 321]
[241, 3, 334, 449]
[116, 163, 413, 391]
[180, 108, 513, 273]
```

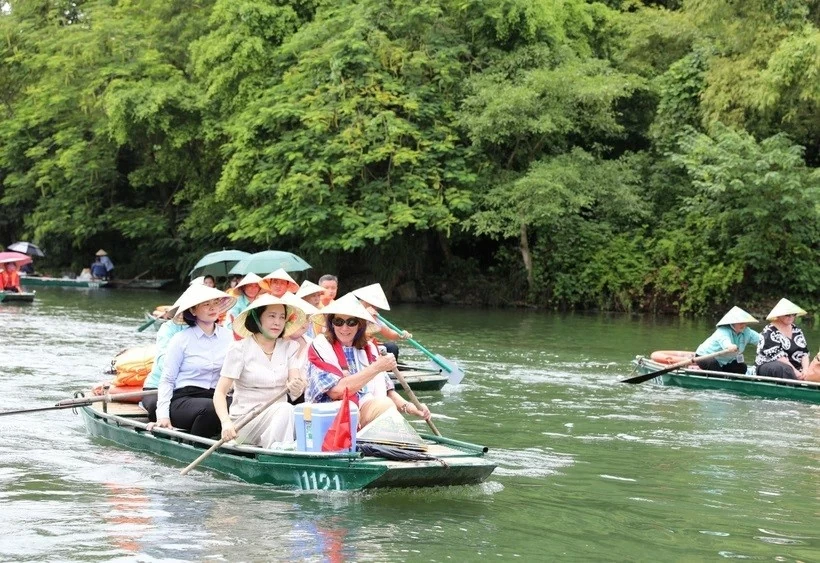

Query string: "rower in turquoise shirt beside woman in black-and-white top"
[695, 307, 760, 373]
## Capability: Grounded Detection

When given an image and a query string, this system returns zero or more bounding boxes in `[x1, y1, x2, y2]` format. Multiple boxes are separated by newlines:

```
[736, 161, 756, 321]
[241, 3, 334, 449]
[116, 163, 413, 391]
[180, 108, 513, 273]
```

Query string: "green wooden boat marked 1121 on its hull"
[78, 403, 495, 491]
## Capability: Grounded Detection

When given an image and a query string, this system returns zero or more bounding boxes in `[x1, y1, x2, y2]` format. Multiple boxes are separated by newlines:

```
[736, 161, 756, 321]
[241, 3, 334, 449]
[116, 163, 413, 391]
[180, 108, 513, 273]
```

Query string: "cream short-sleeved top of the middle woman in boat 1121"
[220, 338, 302, 419]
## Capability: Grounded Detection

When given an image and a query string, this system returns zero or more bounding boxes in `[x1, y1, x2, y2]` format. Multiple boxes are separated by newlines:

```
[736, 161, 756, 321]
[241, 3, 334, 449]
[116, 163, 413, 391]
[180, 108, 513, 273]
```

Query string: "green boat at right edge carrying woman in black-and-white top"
[634, 356, 820, 403]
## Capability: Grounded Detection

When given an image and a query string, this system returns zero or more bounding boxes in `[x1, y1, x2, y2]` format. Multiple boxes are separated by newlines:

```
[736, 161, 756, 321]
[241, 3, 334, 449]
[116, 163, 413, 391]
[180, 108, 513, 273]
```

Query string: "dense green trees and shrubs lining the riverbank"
[0, 0, 820, 313]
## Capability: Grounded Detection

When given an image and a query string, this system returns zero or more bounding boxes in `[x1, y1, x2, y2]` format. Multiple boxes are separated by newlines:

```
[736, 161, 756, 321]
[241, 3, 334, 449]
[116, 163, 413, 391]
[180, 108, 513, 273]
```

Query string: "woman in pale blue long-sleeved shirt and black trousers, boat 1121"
[151, 284, 236, 437]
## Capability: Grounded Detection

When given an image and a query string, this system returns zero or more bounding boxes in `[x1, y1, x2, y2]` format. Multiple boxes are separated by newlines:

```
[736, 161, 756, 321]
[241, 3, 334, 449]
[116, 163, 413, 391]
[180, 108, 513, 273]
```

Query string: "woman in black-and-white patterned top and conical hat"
[755, 298, 810, 379]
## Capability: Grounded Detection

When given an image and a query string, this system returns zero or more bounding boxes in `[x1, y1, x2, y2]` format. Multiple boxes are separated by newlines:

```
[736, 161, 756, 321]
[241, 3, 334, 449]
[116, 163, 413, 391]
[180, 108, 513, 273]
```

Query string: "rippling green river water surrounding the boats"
[0, 288, 820, 561]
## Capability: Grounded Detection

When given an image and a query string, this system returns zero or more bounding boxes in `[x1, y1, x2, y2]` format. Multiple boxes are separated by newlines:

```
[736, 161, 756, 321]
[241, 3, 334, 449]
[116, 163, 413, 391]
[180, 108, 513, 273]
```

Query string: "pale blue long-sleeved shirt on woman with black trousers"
[157, 325, 233, 420]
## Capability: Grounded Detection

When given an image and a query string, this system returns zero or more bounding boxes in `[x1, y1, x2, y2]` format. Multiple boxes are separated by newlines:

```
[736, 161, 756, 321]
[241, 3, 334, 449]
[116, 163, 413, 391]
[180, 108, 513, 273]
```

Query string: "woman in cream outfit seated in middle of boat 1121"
[214, 295, 307, 449]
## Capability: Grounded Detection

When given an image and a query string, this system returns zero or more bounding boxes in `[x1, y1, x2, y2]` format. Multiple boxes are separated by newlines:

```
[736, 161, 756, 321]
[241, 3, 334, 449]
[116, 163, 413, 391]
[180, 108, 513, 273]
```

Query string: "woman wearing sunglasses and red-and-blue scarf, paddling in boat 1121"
[305, 293, 430, 427]
